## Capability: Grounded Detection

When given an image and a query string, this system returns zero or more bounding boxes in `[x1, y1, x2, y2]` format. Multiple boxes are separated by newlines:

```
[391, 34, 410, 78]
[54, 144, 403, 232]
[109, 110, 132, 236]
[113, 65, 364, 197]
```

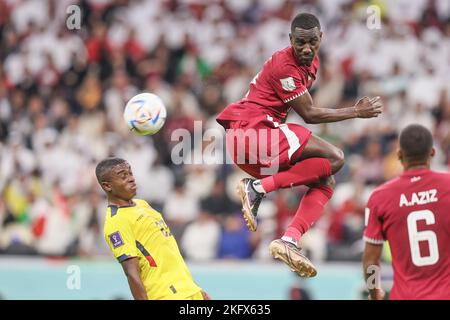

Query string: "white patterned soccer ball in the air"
[123, 93, 167, 136]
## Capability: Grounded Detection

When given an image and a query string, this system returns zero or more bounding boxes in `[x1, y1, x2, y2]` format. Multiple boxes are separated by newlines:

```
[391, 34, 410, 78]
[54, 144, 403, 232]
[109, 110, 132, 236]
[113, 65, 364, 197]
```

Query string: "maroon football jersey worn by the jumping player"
[217, 47, 319, 129]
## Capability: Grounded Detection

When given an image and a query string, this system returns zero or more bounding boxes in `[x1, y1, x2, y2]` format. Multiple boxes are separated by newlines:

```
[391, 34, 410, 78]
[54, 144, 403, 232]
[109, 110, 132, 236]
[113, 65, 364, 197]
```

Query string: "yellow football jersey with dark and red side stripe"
[104, 199, 201, 300]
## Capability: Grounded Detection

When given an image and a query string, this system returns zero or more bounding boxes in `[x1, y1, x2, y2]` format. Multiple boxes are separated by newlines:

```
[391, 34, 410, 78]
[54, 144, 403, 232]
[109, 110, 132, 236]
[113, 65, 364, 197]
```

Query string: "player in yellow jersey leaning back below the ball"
[95, 158, 209, 300]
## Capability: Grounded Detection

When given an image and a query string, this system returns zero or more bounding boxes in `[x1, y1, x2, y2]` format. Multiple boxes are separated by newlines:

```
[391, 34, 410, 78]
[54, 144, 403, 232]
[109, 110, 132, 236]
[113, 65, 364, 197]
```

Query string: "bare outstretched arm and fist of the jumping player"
[287, 92, 383, 123]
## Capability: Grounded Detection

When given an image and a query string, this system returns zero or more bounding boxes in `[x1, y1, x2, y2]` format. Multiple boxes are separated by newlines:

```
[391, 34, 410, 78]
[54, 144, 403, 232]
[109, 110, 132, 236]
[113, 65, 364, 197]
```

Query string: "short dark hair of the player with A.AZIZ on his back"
[400, 124, 433, 161]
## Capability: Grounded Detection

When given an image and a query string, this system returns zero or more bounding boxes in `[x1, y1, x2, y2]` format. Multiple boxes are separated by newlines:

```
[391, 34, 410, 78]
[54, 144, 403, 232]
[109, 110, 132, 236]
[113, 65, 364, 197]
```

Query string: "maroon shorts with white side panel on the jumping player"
[226, 119, 311, 179]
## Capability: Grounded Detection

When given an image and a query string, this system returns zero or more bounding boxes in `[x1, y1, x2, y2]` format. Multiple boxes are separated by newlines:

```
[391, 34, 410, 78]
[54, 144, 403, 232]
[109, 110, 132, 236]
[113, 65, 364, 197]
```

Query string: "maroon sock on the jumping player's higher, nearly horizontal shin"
[260, 158, 331, 192]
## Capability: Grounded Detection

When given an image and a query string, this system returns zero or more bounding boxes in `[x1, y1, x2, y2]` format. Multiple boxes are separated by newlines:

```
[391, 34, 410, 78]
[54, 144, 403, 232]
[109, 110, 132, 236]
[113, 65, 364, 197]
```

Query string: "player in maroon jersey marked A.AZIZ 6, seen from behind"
[363, 124, 450, 300]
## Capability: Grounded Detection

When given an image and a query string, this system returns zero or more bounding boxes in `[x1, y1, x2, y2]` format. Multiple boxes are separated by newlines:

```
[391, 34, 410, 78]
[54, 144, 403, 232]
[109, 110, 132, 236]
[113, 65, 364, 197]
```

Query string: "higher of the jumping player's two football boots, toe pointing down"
[237, 178, 264, 231]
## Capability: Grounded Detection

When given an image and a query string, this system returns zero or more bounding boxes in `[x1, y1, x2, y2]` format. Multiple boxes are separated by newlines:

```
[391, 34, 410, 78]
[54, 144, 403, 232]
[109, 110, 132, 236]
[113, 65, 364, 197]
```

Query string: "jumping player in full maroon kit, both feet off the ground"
[217, 13, 382, 277]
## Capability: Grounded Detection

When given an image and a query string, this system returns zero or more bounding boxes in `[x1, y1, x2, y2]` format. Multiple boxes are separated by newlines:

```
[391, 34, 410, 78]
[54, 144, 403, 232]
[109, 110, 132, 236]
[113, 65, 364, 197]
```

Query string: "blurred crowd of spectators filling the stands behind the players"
[0, 0, 450, 261]
